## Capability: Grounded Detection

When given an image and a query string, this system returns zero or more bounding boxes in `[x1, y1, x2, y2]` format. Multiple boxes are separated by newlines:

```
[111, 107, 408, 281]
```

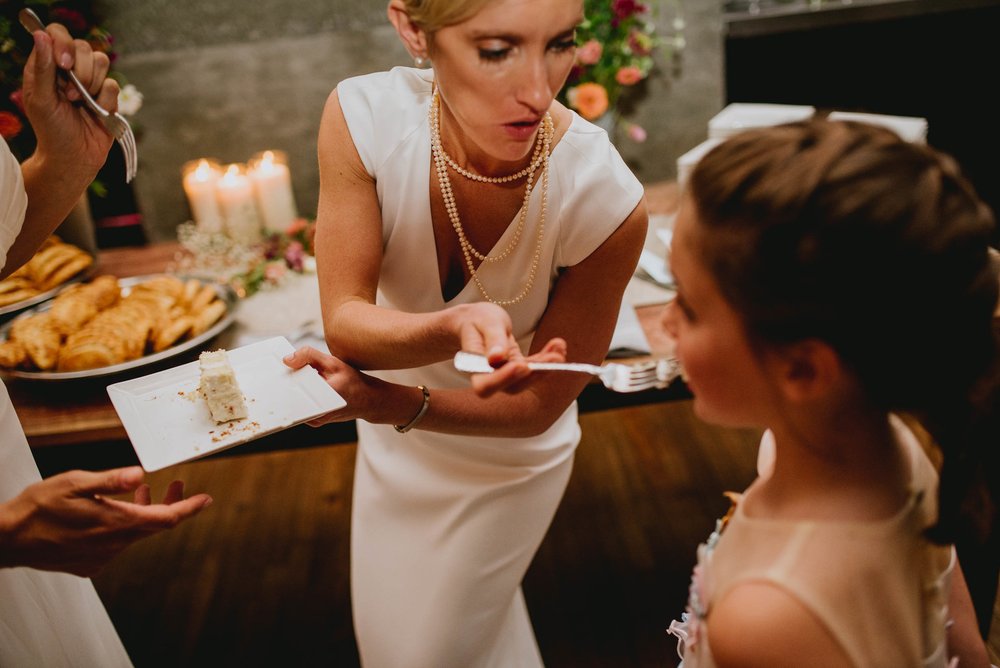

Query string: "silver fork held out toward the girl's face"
[455, 351, 681, 392]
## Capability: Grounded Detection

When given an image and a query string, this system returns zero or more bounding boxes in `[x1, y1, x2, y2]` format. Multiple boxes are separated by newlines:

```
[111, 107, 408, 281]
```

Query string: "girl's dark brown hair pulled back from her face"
[688, 119, 1000, 542]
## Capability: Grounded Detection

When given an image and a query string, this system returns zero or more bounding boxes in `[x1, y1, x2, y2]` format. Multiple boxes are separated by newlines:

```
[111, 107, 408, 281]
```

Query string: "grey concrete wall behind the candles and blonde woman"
[97, 0, 723, 240]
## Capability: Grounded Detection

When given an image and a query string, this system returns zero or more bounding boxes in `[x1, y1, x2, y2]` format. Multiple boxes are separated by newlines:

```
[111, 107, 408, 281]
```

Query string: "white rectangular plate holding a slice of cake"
[108, 336, 347, 471]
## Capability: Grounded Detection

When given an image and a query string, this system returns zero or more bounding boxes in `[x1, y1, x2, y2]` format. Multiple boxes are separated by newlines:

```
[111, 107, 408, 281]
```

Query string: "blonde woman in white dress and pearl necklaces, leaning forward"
[287, 0, 647, 668]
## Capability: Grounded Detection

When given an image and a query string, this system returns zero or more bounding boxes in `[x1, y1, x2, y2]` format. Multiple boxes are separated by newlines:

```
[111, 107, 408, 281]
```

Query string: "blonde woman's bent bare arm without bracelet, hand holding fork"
[316, 91, 516, 369]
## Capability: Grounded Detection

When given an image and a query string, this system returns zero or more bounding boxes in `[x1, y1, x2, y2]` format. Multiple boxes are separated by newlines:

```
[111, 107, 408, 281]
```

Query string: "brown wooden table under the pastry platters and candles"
[5, 243, 686, 459]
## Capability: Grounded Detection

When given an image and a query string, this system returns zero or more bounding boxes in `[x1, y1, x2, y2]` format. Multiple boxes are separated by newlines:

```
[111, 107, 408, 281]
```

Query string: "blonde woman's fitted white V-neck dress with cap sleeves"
[338, 68, 643, 668]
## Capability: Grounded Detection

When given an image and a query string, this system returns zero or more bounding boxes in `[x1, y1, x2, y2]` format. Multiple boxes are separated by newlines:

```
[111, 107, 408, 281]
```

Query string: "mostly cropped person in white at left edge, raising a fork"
[0, 24, 211, 668]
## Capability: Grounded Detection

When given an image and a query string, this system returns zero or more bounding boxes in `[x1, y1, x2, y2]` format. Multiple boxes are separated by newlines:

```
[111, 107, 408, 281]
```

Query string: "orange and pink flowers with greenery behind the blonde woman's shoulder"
[559, 0, 684, 142]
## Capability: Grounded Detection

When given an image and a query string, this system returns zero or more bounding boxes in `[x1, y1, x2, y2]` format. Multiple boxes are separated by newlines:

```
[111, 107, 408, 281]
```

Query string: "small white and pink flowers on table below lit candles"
[175, 218, 316, 297]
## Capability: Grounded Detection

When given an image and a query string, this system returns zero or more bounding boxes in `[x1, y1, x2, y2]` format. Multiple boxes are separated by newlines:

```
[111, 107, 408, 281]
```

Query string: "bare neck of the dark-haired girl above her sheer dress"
[748, 412, 910, 521]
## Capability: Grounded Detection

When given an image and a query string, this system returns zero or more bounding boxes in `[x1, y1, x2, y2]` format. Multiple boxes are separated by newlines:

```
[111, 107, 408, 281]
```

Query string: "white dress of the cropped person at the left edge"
[0, 142, 132, 668]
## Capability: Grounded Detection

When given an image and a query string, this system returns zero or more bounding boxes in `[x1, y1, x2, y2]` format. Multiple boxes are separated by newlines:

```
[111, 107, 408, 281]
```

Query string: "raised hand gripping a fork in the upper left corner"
[24, 23, 118, 173]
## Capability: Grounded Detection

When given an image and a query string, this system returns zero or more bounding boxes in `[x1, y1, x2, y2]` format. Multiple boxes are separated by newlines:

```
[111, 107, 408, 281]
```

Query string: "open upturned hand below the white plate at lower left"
[0, 467, 212, 577]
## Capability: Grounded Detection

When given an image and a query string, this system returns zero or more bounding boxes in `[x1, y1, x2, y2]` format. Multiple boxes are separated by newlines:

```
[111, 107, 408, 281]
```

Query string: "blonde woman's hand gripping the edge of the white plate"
[282, 346, 390, 427]
